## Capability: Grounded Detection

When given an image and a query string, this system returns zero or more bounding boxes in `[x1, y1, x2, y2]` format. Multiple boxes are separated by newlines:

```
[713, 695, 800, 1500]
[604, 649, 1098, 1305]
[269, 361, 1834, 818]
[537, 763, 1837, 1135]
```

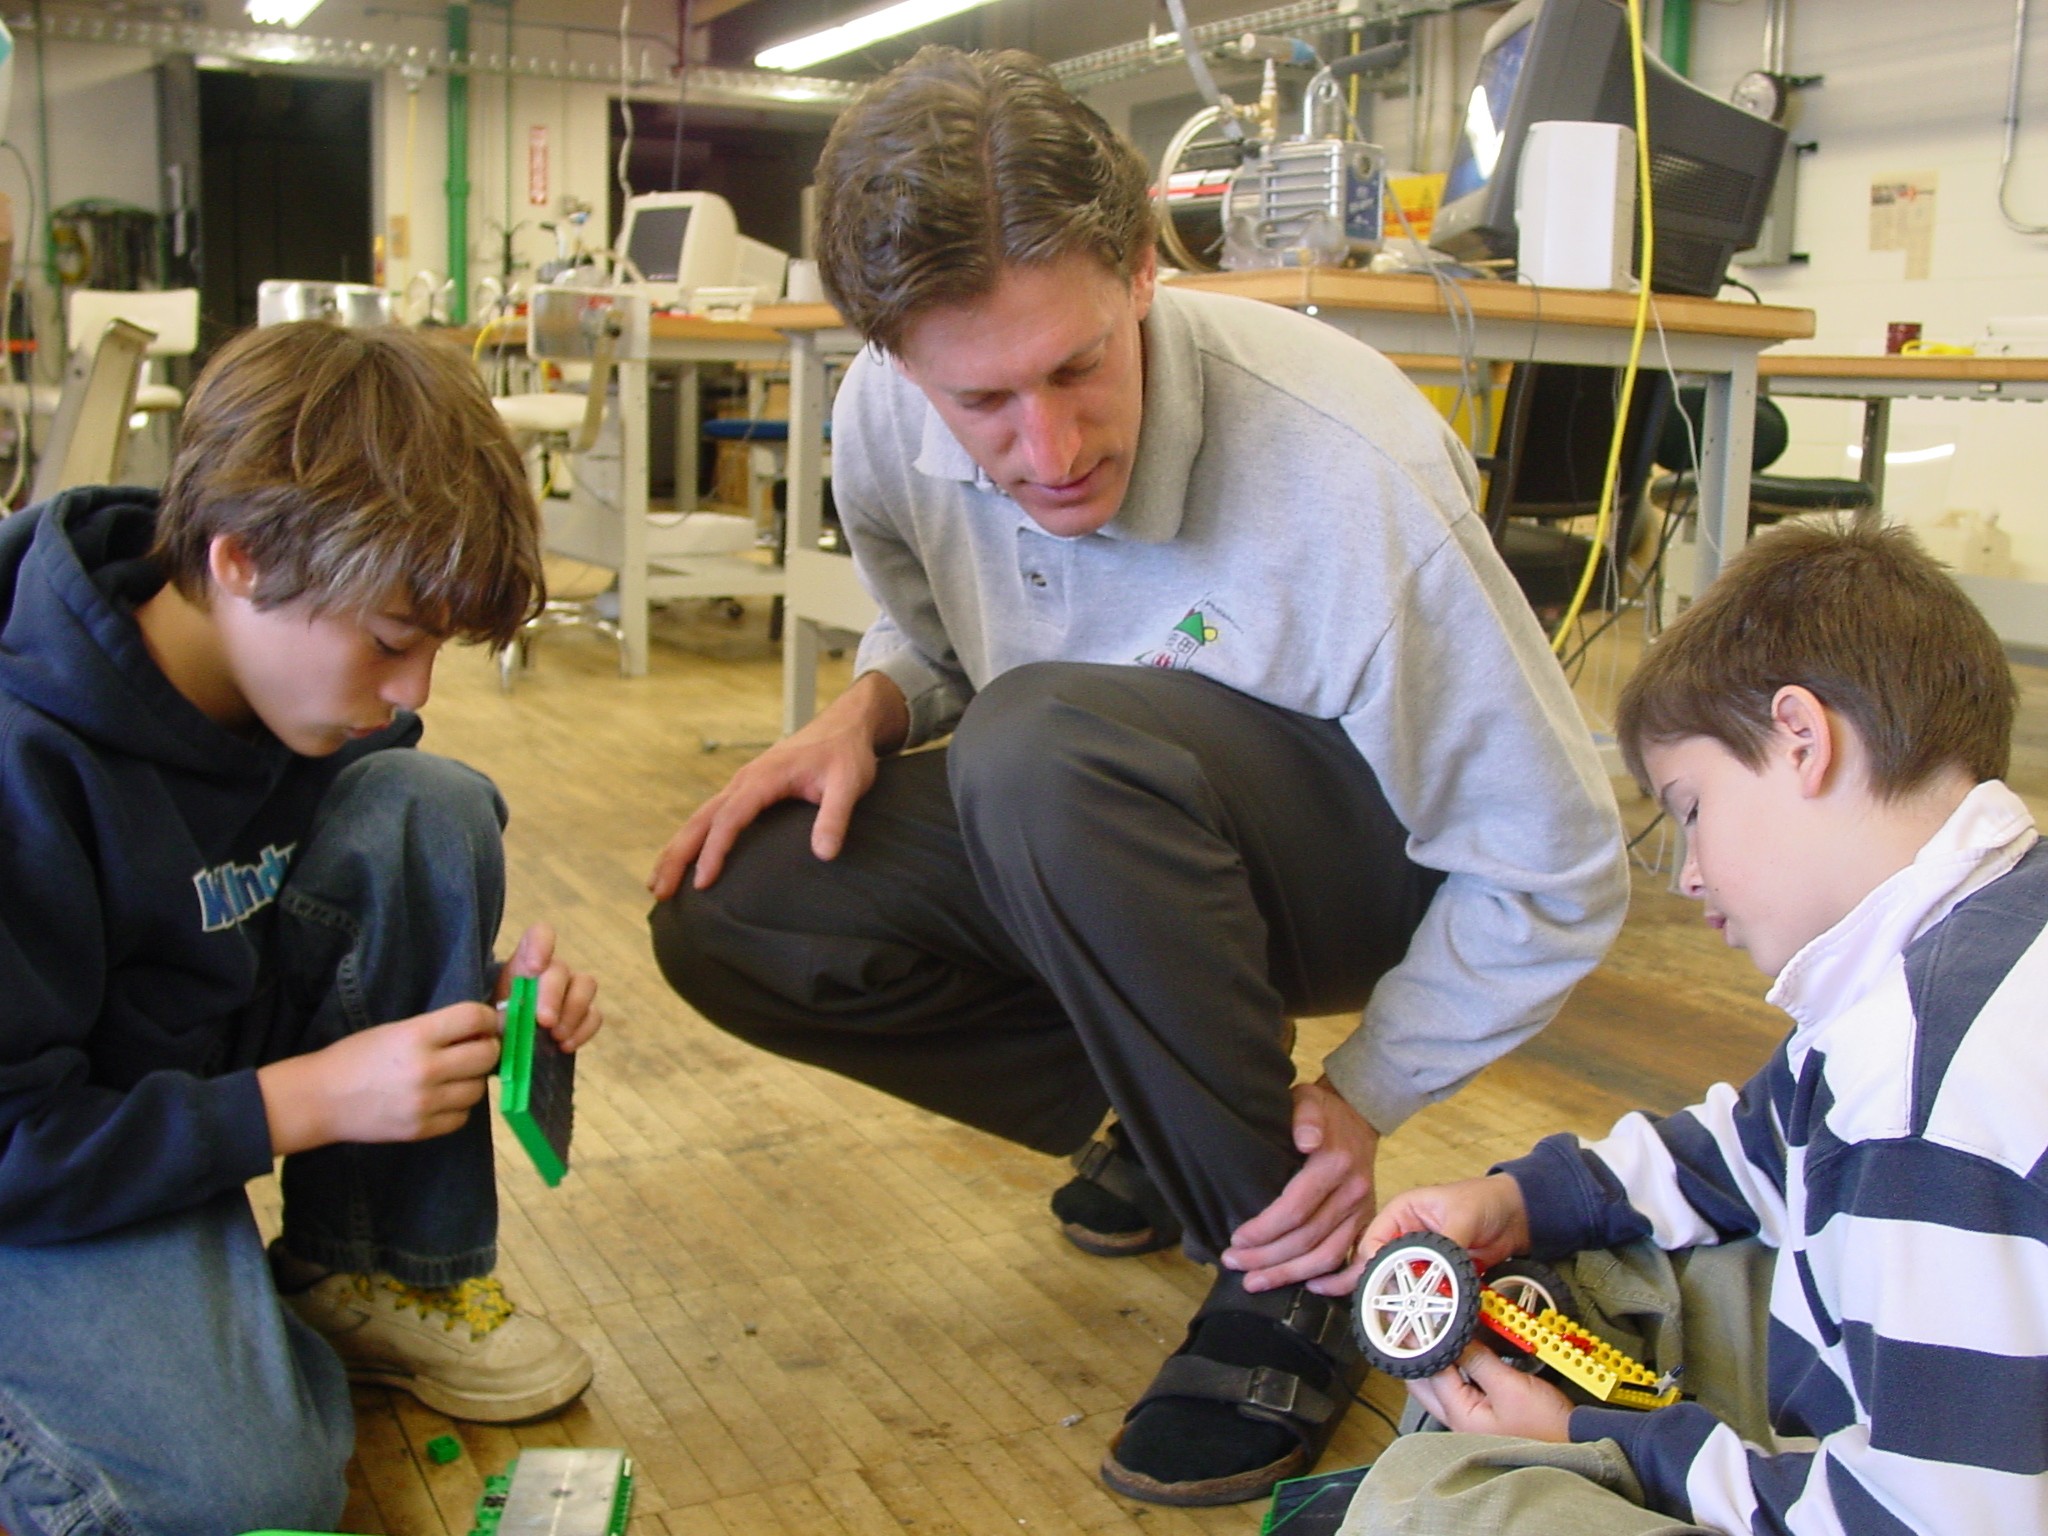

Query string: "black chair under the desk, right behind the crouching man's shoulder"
[1483, 362, 1671, 616]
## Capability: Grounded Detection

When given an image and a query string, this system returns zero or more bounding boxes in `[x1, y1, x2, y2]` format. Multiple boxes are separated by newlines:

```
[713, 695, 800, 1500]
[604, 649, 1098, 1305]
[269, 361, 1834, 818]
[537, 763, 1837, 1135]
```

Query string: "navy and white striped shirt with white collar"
[1507, 782, 2048, 1536]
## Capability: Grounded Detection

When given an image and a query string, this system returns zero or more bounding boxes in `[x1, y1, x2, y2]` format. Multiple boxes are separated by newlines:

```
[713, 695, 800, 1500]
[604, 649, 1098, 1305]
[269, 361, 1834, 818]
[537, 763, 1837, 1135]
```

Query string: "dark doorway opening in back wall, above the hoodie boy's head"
[199, 70, 377, 352]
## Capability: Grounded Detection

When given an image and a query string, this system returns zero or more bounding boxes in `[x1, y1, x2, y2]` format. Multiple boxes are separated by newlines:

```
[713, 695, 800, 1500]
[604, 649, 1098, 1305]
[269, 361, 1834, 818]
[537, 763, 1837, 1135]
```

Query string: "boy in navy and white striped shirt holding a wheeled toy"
[1346, 526, 2048, 1536]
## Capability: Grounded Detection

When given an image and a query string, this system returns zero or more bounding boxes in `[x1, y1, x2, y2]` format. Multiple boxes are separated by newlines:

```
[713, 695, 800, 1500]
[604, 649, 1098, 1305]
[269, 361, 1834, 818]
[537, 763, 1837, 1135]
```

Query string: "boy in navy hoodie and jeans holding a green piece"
[0, 324, 600, 1536]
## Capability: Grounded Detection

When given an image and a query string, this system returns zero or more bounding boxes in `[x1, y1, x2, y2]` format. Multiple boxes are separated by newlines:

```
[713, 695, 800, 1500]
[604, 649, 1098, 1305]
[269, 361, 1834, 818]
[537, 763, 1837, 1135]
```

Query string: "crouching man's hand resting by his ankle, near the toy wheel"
[1223, 1077, 1380, 1296]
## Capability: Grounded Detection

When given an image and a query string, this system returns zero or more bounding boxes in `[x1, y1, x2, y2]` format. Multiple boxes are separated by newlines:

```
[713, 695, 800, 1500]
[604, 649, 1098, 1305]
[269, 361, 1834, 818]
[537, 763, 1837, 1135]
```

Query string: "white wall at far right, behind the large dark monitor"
[1692, 0, 2048, 582]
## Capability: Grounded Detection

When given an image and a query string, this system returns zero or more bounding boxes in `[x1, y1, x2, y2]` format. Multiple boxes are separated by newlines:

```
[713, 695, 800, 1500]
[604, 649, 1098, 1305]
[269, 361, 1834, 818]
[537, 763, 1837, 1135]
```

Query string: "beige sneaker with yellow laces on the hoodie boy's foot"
[283, 1274, 590, 1423]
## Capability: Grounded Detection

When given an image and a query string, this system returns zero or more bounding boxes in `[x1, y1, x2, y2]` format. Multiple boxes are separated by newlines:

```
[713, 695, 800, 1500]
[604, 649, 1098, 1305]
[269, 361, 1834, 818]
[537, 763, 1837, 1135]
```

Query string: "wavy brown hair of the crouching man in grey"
[817, 47, 1153, 352]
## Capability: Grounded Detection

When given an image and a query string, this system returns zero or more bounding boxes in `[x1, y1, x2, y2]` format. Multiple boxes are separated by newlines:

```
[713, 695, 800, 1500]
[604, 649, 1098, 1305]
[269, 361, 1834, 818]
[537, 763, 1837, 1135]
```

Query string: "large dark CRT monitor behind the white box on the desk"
[1430, 0, 1786, 297]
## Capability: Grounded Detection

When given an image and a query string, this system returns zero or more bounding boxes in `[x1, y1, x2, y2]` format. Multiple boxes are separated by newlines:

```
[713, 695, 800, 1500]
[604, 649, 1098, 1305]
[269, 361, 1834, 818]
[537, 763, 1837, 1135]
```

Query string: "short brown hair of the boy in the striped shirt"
[1616, 524, 2019, 799]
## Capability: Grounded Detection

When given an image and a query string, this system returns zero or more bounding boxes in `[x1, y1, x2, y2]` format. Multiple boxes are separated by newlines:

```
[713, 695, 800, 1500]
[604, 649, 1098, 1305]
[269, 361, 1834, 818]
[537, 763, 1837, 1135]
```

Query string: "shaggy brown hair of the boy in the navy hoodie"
[152, 319, 545, 645]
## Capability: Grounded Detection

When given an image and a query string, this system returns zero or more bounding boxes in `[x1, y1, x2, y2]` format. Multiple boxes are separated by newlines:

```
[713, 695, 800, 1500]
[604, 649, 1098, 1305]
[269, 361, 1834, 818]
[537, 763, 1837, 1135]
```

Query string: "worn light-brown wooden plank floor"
[258, 610, 2048, 1536]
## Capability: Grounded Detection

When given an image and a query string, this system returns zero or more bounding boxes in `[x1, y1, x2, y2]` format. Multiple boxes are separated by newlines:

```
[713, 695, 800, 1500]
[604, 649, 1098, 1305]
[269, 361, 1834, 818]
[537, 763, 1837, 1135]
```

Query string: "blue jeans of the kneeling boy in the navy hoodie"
[0, 750, 504, 1536]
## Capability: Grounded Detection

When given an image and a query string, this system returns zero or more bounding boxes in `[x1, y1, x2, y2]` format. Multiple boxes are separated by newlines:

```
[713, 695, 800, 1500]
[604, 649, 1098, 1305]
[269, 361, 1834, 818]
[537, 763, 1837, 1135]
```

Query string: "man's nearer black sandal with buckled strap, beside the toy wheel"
[1102, 1270, 1366, 1505]
